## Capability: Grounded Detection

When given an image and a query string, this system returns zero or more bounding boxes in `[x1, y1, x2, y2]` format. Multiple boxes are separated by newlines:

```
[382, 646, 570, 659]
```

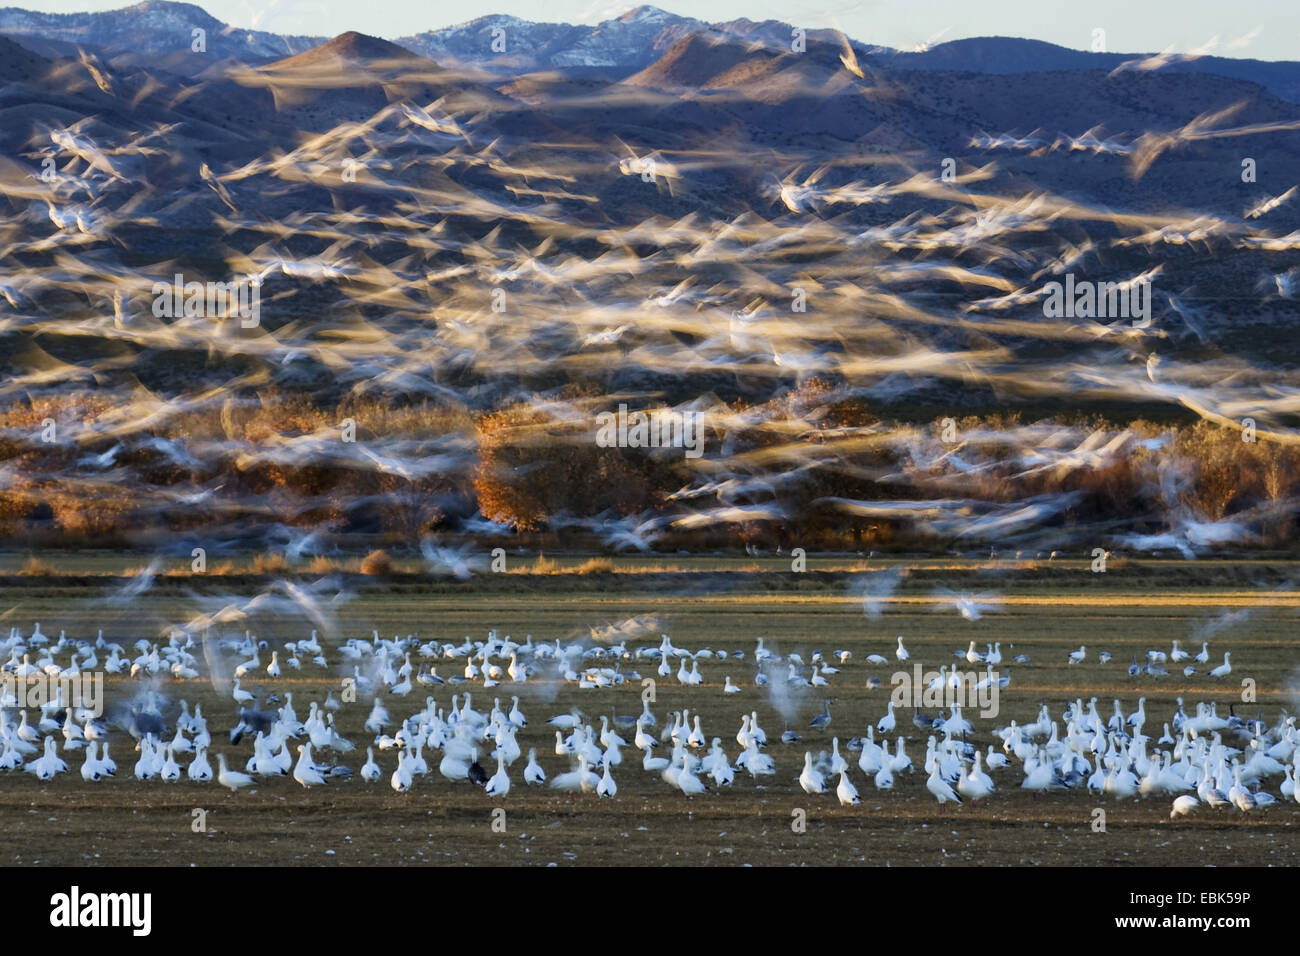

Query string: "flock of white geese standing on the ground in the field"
[0, 624, 1300, 817]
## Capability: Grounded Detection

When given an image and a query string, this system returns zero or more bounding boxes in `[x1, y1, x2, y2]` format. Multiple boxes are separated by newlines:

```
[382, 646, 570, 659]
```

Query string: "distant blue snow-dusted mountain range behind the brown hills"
[0, 0, 1300, 103]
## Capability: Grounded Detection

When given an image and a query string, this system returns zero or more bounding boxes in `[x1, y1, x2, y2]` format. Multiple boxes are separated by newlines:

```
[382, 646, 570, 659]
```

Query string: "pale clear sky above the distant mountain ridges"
[17, 0, 1300, 60]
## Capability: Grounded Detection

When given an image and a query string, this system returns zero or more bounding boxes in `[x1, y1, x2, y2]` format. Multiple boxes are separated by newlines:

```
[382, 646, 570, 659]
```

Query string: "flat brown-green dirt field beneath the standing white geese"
[0, 566, 1300, 866]
